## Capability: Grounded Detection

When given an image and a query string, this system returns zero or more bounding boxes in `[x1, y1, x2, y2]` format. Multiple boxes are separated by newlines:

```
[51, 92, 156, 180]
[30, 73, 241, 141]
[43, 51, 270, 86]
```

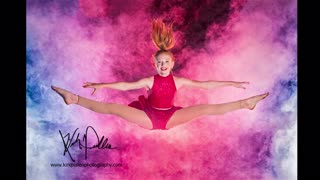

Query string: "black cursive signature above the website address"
[59, 126, 116, 162]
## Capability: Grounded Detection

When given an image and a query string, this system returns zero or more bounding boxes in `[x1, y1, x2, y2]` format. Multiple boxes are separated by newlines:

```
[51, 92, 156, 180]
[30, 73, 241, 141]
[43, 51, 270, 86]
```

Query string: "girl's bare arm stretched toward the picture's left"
[82, 78, 152, 94]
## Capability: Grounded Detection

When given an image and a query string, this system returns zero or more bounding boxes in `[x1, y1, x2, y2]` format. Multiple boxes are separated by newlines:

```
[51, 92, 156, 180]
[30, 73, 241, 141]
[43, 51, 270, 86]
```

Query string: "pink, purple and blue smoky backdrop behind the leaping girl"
[27, 0, 297, 180]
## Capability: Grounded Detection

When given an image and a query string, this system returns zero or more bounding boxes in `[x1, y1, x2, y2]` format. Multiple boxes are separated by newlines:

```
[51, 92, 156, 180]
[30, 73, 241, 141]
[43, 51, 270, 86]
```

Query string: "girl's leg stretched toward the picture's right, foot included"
[166, 93, 269, 129]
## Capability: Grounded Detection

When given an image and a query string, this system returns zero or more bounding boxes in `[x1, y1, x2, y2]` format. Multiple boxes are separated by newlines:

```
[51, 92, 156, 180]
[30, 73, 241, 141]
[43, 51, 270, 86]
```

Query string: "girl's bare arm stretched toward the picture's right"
[175, 77, 249, 89]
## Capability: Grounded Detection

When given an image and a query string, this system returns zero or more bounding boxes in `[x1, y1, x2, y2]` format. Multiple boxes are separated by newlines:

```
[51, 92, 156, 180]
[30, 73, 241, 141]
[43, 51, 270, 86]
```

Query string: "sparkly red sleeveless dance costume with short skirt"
[129, 74, 182, 129]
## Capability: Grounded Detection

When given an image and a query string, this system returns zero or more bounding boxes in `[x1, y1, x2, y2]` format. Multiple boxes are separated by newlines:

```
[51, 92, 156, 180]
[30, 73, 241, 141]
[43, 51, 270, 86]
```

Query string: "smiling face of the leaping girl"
[155, 53, 174, 77]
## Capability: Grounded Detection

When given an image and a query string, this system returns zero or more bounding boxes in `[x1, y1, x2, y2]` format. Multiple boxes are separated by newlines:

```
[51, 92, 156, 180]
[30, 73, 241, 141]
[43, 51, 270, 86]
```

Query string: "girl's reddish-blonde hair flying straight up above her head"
[151, 19, 175, 61]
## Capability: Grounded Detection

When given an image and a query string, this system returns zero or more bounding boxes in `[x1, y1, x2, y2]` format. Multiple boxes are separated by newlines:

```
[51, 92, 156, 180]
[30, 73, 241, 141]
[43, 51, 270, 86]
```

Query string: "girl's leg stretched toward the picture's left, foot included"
[51, 86, 152, 129]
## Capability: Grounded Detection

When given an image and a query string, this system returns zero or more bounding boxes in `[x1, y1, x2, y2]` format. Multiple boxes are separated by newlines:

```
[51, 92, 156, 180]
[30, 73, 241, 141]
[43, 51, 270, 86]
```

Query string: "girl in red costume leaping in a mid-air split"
[51, 19, 269, 129]
